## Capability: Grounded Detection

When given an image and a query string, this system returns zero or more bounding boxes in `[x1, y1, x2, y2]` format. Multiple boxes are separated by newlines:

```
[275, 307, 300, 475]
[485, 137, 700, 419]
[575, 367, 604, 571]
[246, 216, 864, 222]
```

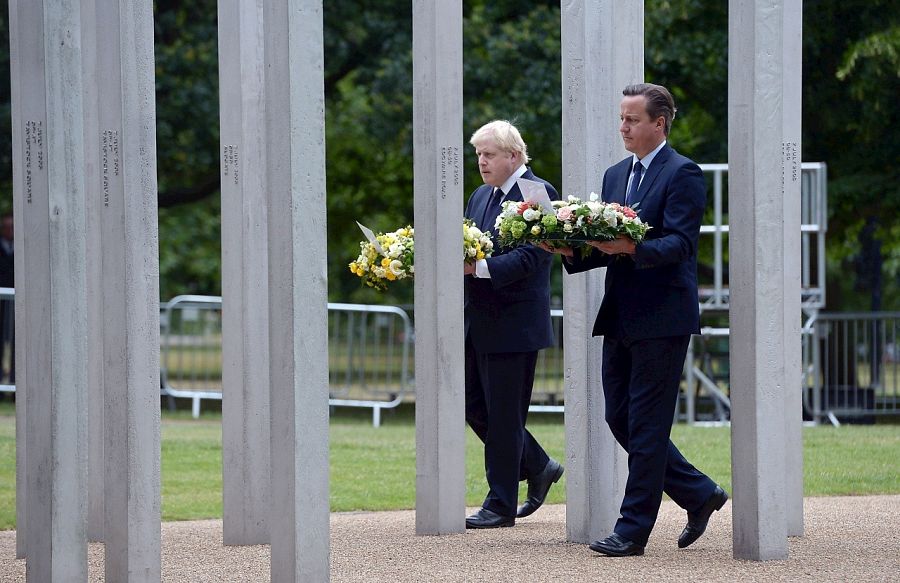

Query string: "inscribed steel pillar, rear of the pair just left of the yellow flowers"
[218, 0, 271, 545]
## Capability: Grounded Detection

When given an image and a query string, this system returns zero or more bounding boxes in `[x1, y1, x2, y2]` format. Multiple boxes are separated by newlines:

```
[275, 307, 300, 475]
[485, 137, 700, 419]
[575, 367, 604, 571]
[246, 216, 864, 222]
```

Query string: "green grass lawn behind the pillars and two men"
[0, 403, 900, 529]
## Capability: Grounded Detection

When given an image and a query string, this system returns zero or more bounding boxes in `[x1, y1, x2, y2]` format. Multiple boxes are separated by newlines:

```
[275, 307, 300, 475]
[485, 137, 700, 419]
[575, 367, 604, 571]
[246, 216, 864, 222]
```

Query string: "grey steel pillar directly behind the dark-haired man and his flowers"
[561, 0, 644, 543]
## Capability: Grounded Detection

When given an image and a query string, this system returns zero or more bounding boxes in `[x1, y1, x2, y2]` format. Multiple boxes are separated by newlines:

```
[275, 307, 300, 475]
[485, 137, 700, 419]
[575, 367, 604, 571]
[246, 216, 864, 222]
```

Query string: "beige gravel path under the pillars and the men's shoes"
[0, 496, 900, 583]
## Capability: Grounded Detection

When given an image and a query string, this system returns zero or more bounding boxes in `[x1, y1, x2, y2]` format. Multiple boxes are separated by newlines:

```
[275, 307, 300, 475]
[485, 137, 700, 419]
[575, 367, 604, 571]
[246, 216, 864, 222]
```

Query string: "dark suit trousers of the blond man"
[466, 338, 550, 516]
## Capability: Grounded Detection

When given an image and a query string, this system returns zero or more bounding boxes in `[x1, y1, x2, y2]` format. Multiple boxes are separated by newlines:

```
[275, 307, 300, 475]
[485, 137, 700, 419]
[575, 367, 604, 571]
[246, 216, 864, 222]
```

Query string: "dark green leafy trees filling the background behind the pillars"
[0, 0, 900, 309]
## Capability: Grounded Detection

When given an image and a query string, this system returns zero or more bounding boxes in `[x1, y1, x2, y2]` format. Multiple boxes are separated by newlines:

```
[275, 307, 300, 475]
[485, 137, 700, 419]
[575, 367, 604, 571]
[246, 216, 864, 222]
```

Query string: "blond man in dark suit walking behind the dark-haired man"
[464, 121, 563, 528]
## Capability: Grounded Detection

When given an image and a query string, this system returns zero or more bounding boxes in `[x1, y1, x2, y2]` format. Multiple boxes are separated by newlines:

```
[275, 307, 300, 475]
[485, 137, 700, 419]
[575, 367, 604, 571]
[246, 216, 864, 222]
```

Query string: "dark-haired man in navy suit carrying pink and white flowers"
[544, 84, 728, 557]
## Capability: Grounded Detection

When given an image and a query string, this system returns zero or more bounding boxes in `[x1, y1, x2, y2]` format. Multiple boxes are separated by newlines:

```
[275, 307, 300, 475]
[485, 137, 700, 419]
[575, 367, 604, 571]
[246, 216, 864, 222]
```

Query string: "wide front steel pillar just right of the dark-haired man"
[728, 0, 797, 560]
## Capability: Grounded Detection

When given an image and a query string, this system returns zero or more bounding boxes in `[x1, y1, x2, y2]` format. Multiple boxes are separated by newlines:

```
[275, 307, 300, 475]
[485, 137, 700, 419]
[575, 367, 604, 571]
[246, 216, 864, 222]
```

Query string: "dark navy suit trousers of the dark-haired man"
[603, 336, 716, 545]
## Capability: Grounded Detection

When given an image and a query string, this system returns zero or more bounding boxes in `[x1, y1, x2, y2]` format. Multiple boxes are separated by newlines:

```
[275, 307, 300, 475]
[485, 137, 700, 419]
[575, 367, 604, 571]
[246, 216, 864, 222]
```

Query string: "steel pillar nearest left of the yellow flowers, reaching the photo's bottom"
[263, 0, 330, 582]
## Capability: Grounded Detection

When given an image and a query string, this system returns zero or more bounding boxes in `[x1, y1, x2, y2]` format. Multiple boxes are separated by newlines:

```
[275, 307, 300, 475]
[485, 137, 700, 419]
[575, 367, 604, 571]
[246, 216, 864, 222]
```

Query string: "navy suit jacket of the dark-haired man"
[563, 144, 706, 340]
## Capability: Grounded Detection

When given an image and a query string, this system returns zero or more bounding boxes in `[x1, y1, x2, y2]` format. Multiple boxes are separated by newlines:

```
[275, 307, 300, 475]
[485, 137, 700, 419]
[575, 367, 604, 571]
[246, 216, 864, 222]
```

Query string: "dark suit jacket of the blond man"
[465, 169, 559, 353]
